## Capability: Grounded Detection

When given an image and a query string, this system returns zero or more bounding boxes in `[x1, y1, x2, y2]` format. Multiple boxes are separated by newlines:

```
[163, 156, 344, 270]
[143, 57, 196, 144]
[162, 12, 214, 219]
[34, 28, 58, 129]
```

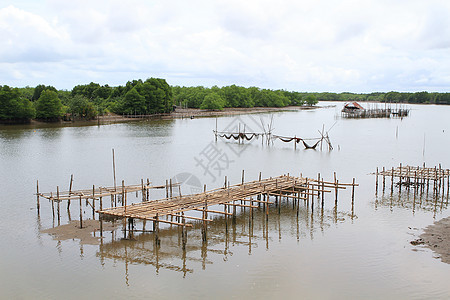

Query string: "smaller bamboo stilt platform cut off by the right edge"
[373, 164, 450, 201]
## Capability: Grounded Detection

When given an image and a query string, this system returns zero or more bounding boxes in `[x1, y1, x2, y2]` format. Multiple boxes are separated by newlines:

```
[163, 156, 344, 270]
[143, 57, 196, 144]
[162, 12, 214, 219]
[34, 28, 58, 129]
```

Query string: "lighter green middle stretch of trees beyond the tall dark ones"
[172, 85, 317, 110]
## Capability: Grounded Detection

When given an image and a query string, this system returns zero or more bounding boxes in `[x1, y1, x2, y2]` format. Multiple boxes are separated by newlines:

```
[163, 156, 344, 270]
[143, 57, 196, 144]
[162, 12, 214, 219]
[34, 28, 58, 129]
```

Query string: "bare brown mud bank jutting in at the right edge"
[411, 217, 450, 264]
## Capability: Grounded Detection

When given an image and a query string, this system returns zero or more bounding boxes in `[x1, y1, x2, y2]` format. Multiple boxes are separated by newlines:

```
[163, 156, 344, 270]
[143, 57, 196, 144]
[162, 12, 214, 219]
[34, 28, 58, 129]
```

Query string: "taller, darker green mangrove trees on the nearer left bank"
[0, 78, 172, 123]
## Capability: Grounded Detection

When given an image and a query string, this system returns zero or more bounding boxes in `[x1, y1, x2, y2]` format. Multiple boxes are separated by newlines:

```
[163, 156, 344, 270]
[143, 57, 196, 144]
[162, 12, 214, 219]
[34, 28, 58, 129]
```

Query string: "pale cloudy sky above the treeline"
[0, 0, 450, 93]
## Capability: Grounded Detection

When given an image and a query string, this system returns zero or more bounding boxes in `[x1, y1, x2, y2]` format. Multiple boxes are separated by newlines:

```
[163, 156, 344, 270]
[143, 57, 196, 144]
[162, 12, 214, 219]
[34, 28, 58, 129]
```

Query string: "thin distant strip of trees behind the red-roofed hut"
[313, 91, 450, 104]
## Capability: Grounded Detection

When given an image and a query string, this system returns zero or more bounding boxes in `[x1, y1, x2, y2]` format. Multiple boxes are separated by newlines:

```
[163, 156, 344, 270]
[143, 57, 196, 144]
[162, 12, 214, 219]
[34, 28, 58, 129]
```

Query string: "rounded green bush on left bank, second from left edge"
[35, 89, 63, 121]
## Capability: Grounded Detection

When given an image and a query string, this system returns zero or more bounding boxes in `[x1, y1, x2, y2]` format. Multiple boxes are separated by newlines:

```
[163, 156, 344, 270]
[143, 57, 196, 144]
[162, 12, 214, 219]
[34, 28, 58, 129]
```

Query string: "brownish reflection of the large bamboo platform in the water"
[97, 201, 356, 278]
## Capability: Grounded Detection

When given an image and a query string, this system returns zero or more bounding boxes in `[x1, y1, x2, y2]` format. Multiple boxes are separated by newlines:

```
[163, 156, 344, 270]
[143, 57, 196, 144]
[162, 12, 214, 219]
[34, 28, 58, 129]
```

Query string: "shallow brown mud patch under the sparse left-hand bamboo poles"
[41, 220, 119, 245]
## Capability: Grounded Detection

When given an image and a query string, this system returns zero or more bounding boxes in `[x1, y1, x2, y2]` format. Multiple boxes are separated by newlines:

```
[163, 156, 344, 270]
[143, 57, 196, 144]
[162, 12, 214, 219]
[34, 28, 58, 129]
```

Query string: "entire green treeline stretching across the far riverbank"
[0, 78, 450, 123]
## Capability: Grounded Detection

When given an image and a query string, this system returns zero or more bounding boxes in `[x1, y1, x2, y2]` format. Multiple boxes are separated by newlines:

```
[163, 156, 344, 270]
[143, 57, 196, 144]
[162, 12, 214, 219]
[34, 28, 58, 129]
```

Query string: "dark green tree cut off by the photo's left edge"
[0, 85, 35, 121]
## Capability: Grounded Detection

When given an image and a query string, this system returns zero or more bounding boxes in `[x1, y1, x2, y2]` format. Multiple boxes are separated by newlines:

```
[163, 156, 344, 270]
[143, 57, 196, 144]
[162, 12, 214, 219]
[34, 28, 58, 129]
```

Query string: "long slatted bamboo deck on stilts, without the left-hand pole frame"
[98, 172, 357, 247]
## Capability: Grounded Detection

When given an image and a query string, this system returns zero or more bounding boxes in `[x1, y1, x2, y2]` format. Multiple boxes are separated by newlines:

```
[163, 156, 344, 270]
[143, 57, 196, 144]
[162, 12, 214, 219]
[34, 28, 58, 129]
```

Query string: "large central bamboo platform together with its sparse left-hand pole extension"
[36, 170, 358, 247]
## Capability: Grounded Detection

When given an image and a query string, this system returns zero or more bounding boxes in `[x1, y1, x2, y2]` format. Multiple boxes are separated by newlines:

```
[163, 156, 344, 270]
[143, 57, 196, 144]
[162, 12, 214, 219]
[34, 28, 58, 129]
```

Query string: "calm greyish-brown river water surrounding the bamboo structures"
[0, 102, 450, 299]
